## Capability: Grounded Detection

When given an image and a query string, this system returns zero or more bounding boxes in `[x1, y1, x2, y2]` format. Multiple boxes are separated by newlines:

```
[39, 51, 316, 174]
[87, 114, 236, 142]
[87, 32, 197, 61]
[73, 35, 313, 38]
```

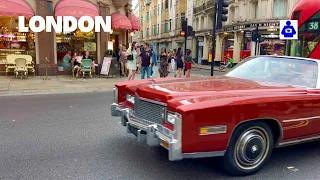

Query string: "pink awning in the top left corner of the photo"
[0, 0, 34, 18]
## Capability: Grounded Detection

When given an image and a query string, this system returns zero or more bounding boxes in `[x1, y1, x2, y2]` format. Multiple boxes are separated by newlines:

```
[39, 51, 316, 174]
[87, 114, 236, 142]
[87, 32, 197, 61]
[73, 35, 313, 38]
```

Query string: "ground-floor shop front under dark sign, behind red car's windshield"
[215, 21, 285, 64]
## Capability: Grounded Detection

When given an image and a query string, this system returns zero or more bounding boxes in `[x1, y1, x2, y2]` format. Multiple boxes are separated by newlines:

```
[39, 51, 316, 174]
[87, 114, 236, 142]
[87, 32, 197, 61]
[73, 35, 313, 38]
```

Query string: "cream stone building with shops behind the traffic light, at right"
[193, 0, 298, 64]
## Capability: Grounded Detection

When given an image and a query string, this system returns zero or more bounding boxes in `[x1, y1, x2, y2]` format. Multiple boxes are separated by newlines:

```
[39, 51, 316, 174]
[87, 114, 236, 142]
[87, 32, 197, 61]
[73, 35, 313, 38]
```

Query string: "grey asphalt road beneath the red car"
[0, 92, 320, 180]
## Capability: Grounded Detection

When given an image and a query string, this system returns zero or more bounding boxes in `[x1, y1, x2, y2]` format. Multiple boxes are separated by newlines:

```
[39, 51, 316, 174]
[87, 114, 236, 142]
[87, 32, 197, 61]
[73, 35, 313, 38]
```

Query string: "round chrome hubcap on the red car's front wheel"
[234, 127, 270, 170]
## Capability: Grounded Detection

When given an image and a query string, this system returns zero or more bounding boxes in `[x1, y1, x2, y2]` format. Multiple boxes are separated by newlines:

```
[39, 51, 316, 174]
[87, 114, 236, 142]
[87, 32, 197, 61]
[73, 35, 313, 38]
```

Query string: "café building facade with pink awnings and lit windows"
[0, 0, 139, 75]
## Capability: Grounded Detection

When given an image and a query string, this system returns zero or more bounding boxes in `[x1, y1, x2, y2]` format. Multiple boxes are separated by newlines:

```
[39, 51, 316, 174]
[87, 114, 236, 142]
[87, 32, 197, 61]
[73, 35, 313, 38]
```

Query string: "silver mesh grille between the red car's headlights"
[134, 97, 166, 124]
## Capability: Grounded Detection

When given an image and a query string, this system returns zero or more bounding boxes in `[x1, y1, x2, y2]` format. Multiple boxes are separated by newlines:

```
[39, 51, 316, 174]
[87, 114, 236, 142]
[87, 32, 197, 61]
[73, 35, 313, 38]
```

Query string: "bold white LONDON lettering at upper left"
[18, 16, 111, 33]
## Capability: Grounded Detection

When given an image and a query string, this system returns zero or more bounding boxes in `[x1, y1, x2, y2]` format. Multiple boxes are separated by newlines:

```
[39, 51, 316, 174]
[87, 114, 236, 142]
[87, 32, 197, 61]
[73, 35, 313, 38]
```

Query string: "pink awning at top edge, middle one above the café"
[54, 0, 99, 19]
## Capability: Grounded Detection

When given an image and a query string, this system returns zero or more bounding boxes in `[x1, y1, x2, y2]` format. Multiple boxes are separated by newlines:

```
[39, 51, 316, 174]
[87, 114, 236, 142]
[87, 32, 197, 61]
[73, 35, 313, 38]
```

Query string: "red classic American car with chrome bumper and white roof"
[111, 56, 320, 175]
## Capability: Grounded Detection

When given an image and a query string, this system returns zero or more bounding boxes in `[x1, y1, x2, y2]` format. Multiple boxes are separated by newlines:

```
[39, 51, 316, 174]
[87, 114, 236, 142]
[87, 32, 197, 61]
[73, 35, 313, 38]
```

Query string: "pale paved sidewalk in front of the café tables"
[0, 68, 206, 96]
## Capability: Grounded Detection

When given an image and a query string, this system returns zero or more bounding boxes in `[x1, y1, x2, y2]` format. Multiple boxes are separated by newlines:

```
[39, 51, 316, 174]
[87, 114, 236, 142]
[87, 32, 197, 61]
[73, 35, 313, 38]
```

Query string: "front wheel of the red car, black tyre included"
[223, 121, 274, 175]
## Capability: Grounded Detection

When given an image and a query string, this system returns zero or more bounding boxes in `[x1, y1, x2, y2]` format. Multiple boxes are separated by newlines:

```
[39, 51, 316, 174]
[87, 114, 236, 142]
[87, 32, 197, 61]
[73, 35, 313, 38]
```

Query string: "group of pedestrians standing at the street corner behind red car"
[116, 42, 196, 81]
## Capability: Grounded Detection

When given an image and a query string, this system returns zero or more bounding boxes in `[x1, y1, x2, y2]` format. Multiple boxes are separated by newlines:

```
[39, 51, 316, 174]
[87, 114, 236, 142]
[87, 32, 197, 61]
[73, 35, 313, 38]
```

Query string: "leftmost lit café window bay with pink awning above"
[0, 0, 36, 74]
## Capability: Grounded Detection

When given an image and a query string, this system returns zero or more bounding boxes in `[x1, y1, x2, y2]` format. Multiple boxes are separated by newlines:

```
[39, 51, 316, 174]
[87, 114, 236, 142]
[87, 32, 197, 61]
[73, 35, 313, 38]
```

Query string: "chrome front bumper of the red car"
[111, 103, 183, 161]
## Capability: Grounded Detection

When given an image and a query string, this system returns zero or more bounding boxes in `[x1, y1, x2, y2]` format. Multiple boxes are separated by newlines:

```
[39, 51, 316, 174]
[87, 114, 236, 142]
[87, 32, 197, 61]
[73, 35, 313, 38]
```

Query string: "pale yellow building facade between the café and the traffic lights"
[139, 0, 191, 54]
